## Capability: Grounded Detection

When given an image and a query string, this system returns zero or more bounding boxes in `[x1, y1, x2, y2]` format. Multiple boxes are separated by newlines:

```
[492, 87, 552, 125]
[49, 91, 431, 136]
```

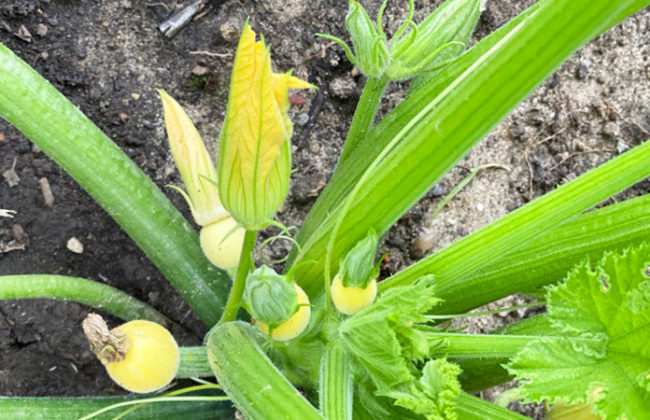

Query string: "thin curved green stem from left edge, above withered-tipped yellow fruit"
[0, 274, 169, 325]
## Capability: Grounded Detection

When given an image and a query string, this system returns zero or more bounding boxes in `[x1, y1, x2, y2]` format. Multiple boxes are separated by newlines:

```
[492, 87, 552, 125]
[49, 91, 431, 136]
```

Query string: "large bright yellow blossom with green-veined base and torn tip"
[217, 23, 313, 230]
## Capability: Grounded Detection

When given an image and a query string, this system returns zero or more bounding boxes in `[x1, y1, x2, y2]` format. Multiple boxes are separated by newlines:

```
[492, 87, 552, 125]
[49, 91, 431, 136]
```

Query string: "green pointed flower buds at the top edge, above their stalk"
[322, 0, 485, 80]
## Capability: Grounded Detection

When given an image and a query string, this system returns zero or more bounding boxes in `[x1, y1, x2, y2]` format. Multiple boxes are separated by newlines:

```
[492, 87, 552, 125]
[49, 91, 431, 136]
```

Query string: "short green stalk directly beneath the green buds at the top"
[339, 77, 390, 164]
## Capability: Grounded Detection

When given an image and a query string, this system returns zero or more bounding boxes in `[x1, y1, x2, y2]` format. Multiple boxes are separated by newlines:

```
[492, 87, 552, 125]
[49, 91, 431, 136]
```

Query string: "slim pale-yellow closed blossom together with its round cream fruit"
[159, 90, 244, 269]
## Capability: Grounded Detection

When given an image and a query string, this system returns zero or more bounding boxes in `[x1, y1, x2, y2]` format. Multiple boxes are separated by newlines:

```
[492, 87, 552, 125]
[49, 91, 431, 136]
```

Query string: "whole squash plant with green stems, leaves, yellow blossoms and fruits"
[0, 0, 650, 420]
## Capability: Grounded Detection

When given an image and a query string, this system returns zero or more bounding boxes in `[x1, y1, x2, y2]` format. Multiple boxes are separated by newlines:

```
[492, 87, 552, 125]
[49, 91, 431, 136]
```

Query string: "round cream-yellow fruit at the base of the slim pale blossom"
[199, 217, 246, 270]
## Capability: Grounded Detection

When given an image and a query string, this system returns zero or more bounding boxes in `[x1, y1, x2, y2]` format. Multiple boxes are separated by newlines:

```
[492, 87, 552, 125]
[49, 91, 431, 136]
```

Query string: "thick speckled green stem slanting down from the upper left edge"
[0, 45, 229, 325]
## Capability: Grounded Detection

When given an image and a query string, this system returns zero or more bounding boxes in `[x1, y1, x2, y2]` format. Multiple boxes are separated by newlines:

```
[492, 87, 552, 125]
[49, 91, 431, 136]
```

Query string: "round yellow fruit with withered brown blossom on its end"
[82, 314, 180, 394]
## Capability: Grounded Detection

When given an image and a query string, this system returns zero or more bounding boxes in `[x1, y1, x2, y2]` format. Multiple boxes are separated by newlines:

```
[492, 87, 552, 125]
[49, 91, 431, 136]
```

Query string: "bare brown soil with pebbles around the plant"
[0, 0, 650, 416]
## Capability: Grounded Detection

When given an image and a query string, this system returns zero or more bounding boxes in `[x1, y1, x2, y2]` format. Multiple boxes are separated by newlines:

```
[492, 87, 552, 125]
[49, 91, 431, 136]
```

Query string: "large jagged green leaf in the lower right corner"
[508, 244, 650, 420]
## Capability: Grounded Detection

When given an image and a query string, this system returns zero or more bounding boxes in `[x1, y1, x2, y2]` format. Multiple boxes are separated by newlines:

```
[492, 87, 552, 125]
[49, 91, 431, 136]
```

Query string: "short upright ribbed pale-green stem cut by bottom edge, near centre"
[319, 345, 353, 420]
